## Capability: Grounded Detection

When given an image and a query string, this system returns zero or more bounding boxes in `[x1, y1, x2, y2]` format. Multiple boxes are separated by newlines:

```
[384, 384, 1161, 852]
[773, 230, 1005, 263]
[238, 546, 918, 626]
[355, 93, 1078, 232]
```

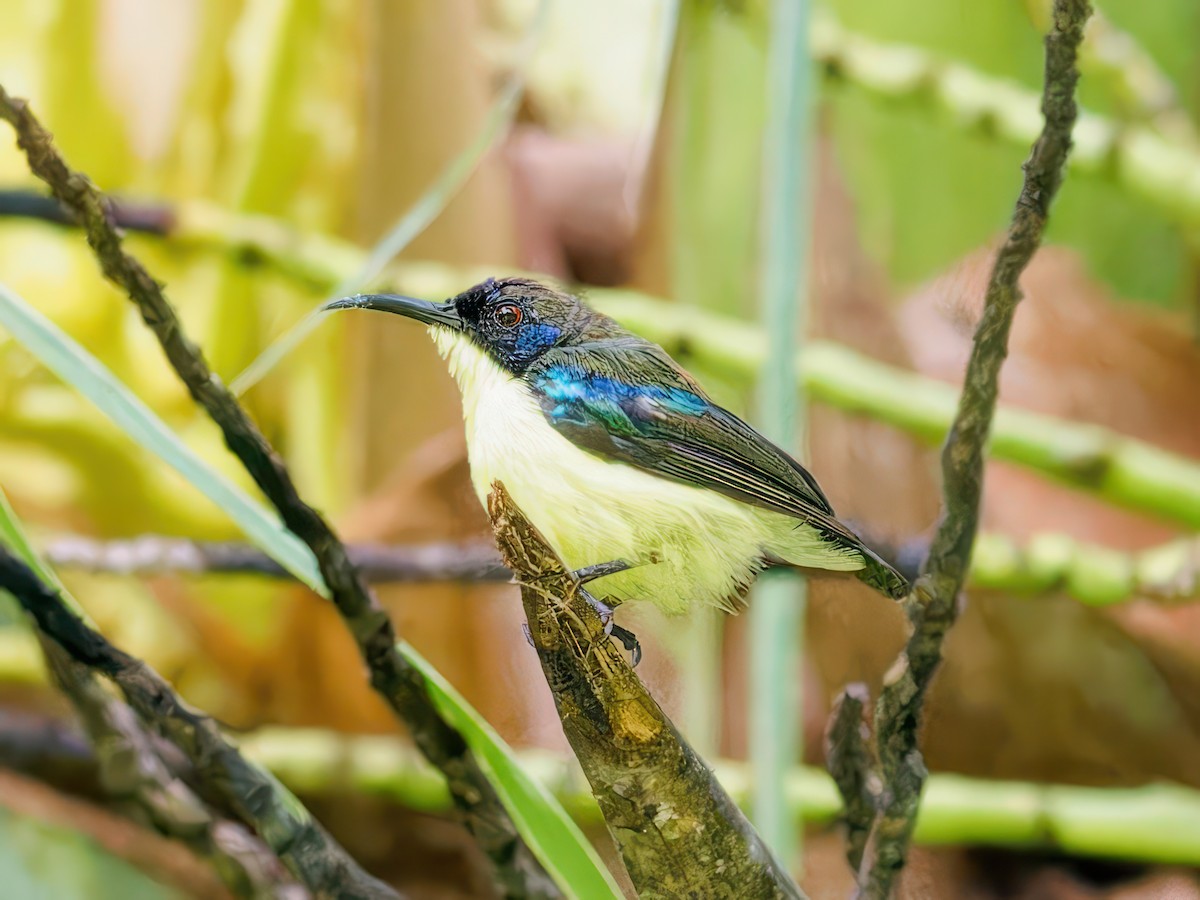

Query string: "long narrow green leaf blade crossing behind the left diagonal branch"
[0, 284, 622, 898]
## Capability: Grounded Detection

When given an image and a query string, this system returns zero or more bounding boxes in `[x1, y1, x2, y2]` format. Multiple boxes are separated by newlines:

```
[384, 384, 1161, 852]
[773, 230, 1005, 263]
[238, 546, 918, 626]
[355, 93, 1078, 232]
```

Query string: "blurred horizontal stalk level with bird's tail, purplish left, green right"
[42, 529, 1200, 606]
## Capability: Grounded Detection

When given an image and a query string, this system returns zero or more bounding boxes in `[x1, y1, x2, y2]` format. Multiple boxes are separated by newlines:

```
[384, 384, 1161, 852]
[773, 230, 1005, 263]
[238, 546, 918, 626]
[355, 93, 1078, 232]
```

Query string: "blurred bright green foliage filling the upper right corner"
[827, 0, 1200, 306]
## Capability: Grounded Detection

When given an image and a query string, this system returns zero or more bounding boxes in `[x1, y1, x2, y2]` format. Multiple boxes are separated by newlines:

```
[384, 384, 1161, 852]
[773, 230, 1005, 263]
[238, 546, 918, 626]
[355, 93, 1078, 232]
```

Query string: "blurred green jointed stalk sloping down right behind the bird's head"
[10, 194, 1200, 528]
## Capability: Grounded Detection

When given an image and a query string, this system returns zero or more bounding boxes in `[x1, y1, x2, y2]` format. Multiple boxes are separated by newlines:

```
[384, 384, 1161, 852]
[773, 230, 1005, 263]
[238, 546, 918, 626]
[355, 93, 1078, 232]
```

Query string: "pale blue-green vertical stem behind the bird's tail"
[750, 0, 812, 859]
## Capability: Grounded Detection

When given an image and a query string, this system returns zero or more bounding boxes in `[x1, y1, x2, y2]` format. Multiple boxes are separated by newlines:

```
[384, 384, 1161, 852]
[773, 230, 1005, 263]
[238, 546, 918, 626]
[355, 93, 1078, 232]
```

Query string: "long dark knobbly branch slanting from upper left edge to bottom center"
[0, 82, 559, 896]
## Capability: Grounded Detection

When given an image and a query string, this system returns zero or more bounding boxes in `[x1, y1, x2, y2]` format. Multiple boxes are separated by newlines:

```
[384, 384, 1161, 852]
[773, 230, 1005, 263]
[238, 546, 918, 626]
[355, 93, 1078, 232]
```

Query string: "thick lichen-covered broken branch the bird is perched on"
[488, 482, 803, 898]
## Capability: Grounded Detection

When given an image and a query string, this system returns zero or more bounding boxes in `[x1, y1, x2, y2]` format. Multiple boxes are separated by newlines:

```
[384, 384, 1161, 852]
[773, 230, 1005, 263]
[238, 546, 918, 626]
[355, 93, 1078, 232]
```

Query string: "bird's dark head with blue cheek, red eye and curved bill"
[325, 278, 617, 374]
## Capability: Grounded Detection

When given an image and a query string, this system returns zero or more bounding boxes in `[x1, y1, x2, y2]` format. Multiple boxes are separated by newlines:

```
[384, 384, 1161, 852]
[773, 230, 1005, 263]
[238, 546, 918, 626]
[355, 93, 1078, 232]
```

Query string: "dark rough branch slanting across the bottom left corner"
[0, 545, 397, 900]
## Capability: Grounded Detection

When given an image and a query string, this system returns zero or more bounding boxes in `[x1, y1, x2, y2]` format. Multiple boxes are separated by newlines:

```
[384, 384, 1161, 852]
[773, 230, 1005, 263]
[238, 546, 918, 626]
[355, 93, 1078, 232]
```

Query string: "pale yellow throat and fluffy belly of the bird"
[439, 328, 863, 613]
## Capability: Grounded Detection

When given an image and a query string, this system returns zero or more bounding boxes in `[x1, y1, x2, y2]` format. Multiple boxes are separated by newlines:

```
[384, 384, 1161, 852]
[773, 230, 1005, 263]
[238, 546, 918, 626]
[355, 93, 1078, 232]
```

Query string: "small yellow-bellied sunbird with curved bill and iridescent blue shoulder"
[324, 277, 908, 646]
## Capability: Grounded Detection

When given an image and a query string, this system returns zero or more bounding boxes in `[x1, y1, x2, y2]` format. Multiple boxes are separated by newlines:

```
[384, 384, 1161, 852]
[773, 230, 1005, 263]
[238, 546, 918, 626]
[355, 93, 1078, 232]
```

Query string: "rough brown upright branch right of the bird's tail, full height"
[859, 0, 1091, 900]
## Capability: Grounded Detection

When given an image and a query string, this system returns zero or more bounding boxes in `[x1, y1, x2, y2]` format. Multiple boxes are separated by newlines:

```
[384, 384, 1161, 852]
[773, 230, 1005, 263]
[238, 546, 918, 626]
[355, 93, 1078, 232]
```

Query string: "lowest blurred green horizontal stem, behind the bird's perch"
[241, 728, 1200, 865]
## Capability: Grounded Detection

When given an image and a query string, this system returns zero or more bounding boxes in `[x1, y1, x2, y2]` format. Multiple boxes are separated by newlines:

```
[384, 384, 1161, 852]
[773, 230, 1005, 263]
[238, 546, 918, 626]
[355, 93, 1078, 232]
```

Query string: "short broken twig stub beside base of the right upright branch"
[826, 683, 880, 871]
